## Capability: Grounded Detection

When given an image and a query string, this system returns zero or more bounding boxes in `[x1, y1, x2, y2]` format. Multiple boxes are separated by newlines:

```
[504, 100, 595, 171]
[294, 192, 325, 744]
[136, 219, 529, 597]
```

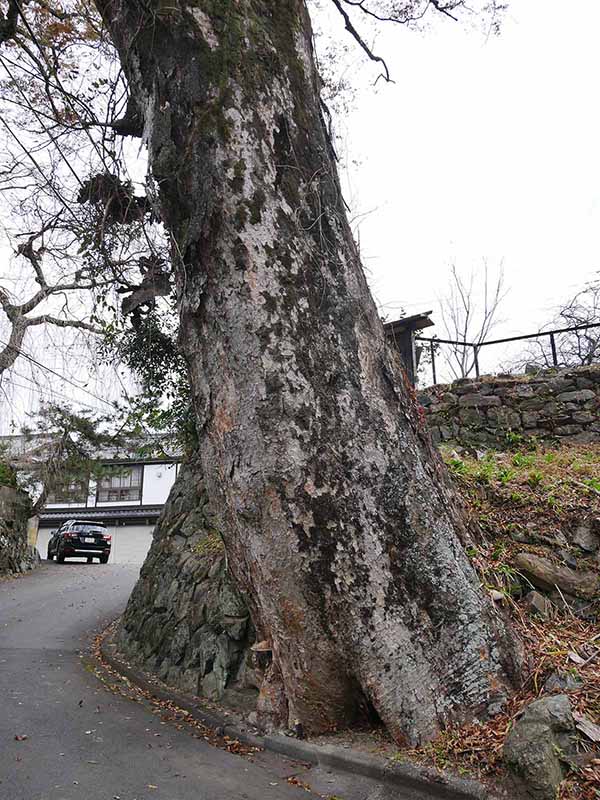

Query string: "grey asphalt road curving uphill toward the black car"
[0, 562, 412, 800]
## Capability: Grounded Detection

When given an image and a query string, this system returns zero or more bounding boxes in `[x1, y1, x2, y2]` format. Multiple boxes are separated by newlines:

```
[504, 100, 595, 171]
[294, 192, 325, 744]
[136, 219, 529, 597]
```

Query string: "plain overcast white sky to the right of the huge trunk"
[338, 0, 600, 350]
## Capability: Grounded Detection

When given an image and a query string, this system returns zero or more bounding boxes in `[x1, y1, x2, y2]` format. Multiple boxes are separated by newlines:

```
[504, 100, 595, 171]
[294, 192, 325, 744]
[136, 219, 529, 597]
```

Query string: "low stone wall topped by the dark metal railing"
[419, 366, 600, 447]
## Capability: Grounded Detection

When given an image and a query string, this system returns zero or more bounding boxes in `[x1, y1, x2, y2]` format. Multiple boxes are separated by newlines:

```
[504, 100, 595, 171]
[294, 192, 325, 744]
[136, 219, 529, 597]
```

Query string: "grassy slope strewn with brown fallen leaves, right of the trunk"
[399, 445, 600, 800]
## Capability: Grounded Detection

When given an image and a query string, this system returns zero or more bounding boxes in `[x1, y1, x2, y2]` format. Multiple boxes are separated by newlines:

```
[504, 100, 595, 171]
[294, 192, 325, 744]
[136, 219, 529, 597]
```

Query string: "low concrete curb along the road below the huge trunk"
[100, 632, 507, 800]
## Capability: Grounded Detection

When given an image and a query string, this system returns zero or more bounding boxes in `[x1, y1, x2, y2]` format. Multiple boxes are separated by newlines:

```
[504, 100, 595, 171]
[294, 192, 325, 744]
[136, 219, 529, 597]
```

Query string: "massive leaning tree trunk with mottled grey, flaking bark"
[97, 0, 518, 742]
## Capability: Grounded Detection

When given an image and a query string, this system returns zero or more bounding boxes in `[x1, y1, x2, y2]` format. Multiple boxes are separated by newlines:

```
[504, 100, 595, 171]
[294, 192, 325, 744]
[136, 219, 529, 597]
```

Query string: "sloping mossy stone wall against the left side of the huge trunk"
[117, 462, 261, 705]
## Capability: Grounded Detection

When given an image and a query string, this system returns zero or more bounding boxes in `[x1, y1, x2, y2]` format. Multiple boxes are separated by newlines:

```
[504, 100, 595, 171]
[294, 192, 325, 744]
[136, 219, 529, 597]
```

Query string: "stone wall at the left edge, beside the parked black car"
[0, 486, 39, 575]
